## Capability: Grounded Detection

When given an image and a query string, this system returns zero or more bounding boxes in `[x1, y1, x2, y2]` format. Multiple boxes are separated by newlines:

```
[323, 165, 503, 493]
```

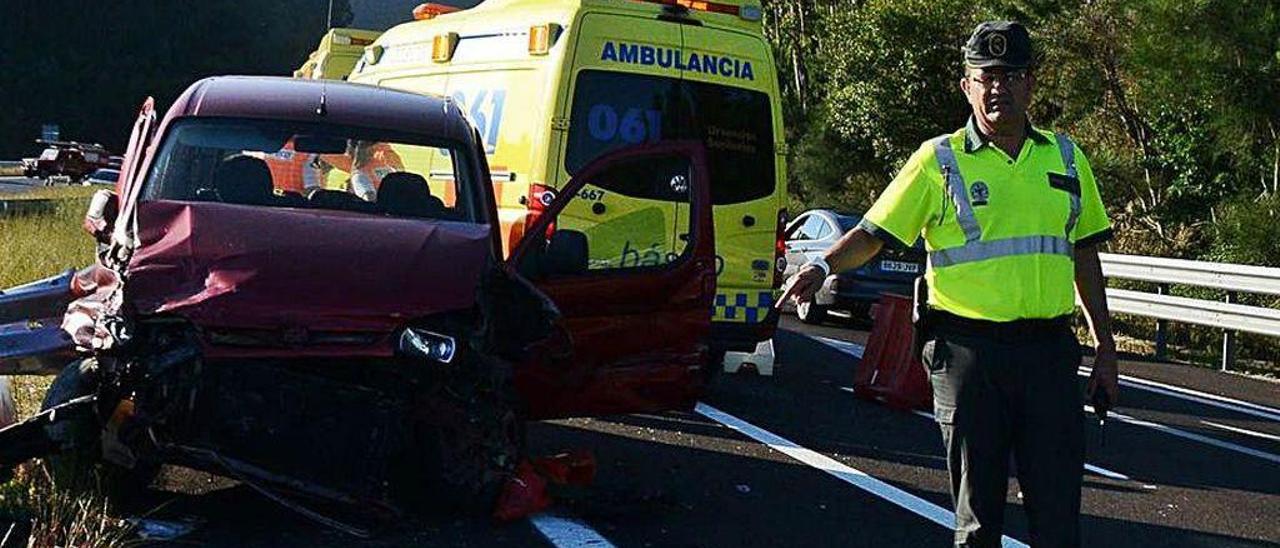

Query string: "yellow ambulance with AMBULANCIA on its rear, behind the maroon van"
[348, 0, 786, 351]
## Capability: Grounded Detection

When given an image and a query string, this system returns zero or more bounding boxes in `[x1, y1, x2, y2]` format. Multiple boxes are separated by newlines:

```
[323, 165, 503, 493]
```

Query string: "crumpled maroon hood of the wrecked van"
[125, 201, 490, 333]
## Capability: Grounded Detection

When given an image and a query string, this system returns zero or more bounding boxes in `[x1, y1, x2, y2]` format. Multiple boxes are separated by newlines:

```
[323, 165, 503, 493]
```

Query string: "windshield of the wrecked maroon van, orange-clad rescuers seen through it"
[142, 118, 480, 222]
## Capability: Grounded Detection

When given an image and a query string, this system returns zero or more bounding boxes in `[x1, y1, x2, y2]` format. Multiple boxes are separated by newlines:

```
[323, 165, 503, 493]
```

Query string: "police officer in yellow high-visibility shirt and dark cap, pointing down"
[780, 20, 1119, 547]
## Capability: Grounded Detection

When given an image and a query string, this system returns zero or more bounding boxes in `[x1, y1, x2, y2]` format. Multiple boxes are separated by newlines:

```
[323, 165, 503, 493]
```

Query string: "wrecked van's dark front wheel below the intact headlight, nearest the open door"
[396, 355, 525, 513]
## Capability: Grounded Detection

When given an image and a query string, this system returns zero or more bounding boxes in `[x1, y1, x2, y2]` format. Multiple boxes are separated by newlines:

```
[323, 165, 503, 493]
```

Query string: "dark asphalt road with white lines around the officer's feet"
[120, 318, 1280, 547]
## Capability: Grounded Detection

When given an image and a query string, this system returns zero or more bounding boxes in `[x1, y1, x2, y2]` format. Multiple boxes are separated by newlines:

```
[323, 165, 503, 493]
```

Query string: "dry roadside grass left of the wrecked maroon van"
[0, 187, 133, 547]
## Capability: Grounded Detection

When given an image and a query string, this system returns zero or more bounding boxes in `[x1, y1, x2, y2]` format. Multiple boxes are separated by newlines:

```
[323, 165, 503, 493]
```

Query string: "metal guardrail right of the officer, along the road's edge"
[1100, 254, 1280, 370]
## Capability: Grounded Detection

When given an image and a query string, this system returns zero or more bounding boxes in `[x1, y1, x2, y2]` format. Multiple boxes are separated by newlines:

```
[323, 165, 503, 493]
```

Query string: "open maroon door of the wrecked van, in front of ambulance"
[506, 142, 716, 419]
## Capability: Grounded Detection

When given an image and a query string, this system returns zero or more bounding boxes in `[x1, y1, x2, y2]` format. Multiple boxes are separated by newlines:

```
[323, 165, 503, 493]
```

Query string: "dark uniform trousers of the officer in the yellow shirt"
[922, 318, 1084, 548]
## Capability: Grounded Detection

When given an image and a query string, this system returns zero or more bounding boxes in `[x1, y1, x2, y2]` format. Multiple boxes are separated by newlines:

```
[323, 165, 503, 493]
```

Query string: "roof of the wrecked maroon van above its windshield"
[165, 76, 470, 141]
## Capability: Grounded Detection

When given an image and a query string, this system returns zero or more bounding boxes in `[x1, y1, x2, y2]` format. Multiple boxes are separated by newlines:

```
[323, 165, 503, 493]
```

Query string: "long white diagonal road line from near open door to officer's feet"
[694, 403, 1027, 547]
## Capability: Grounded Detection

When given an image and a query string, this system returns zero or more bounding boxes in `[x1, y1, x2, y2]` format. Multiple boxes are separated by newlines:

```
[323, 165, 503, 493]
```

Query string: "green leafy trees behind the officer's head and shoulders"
[765, 0, 1280, 264]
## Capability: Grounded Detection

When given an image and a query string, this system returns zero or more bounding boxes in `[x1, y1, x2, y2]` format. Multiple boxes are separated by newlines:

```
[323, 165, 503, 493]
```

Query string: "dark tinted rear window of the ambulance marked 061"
[564, 70, 776, 205]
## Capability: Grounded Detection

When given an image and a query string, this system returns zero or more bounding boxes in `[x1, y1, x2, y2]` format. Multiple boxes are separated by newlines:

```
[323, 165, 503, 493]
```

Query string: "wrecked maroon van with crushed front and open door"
[0, 77, 716, 512]
